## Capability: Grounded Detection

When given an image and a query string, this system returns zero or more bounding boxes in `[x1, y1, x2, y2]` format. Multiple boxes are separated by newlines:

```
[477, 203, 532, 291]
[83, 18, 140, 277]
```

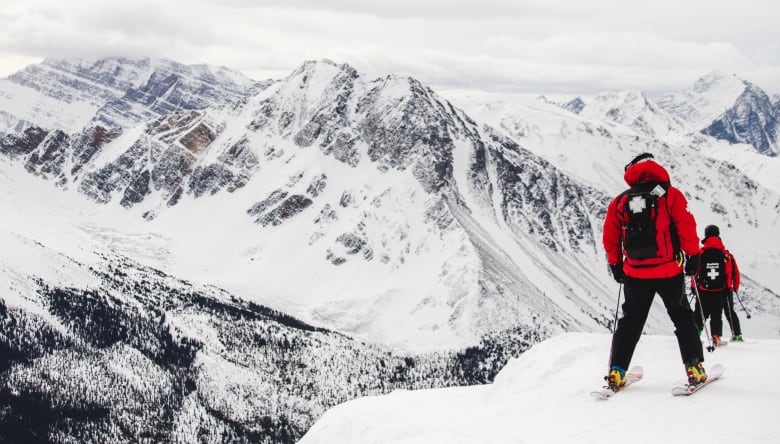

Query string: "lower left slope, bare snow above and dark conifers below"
[0, 153, 542, 444]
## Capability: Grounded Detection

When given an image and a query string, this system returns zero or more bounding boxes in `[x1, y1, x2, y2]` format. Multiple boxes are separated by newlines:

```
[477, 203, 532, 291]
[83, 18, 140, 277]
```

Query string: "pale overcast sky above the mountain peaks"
[0, 0, 780, 96]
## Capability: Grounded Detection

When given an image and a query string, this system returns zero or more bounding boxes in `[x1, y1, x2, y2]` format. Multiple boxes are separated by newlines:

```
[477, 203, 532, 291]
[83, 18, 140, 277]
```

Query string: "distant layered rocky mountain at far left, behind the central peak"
[0, 58, 254, 135]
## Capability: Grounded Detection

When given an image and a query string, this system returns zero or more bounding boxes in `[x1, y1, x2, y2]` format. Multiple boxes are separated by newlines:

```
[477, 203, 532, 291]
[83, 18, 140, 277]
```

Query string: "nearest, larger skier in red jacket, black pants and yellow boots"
[603, 153, 707, 391]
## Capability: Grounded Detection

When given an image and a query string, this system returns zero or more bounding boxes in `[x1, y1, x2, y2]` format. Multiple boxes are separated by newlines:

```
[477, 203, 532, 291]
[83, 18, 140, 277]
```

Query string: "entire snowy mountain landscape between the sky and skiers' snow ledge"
[0, 59, 780, 442]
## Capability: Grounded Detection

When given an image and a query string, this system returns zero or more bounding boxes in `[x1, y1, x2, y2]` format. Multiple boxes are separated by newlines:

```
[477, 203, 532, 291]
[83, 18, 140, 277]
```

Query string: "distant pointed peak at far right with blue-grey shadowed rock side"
[658, 72, 780, 157]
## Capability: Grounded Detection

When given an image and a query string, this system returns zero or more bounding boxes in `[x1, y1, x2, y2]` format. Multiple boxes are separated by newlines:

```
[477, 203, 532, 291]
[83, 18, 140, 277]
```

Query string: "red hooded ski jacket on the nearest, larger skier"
[603, 160, 699, 279]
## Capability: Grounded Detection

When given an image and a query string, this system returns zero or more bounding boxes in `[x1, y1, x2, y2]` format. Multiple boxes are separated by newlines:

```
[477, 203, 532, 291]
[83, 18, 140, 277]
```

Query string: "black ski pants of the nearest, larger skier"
[610, 273, 704, 369]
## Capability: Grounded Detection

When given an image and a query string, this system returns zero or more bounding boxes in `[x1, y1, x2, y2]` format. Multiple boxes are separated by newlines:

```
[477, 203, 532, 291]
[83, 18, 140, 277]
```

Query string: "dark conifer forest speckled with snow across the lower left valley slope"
[0, 255, 544, 443]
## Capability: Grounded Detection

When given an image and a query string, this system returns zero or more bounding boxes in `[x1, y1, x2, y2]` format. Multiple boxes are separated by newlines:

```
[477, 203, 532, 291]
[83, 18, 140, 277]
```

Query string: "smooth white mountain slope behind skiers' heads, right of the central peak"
[449, 90, 780, 293]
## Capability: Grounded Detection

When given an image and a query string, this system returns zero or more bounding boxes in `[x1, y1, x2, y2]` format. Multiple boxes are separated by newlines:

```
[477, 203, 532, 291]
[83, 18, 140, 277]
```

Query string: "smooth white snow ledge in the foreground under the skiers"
[300, 332, 780, 444]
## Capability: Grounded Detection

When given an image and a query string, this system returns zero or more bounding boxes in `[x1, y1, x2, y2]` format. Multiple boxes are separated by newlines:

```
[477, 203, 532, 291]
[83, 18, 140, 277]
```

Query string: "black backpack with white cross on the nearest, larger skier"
[623, 182, 669, 259]
